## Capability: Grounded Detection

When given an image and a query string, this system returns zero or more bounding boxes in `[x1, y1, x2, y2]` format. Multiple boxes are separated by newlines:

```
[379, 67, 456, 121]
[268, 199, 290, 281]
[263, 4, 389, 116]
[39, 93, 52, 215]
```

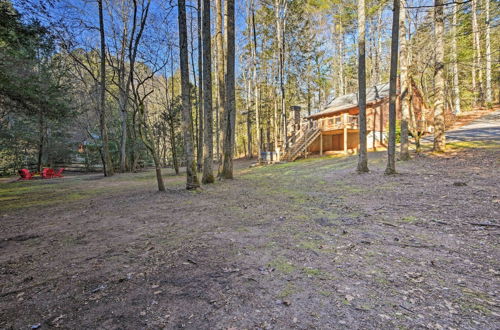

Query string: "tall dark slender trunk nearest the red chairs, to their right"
[97, 0, 113, 176]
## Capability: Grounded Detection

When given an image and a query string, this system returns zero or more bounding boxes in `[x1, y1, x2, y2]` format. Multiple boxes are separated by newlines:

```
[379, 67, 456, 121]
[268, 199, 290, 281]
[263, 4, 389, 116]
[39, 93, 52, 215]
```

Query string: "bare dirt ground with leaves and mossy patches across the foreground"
[0, 142, 500, 329]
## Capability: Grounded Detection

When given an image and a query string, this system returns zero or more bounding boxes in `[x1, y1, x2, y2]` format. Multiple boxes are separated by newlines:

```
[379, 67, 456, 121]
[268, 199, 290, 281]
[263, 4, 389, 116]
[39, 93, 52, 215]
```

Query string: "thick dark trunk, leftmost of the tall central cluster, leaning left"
[178, 0, 200, 189]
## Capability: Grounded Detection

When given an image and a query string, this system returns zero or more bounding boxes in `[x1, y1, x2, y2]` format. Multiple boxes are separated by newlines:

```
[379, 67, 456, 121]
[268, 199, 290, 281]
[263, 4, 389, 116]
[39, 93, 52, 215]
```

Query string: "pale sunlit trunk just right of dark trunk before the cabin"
[399, 0, 410, 160]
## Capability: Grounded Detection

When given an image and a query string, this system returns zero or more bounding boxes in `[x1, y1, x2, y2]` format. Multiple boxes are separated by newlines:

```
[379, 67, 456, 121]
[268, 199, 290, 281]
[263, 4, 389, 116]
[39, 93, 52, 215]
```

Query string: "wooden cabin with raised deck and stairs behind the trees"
[283, 83, 430, 161]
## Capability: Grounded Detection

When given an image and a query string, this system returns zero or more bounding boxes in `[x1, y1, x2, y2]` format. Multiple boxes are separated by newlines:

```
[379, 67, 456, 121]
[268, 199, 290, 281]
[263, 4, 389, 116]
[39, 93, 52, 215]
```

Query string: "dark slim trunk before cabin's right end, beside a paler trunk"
[385, 0, 400, 174]
